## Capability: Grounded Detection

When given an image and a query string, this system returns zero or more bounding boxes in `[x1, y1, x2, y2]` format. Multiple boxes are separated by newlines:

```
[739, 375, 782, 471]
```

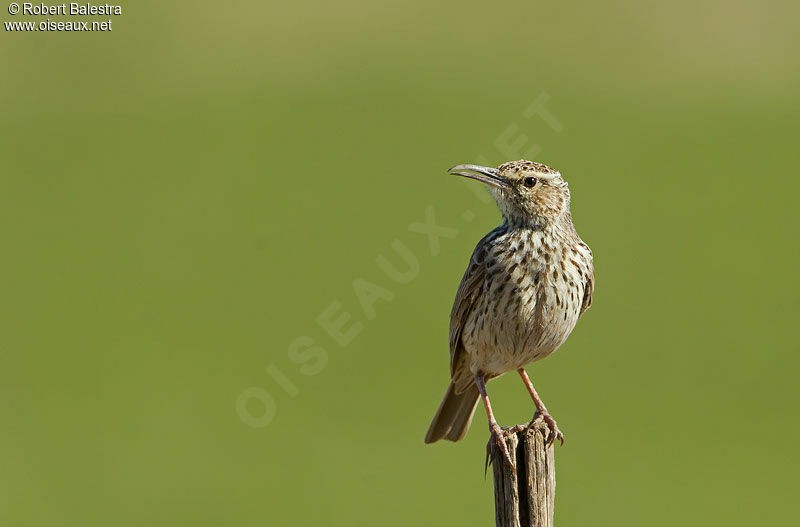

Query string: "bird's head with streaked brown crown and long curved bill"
[449, 160, 569, 227]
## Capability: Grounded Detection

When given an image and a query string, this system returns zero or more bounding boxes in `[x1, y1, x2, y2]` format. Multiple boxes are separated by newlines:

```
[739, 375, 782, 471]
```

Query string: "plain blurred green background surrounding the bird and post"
[0, 0, 800, 527]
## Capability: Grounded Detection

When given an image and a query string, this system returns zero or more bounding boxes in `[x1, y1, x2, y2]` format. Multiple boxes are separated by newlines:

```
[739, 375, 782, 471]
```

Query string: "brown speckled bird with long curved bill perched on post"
[425, 159, 594, 468]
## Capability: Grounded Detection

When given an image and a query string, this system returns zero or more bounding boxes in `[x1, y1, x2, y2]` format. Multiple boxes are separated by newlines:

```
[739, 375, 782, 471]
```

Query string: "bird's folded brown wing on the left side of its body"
[450, 225, 503, 379]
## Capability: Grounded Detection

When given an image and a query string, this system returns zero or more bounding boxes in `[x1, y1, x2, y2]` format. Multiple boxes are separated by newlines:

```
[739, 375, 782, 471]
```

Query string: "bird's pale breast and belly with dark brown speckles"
[454, 216, 592, 392]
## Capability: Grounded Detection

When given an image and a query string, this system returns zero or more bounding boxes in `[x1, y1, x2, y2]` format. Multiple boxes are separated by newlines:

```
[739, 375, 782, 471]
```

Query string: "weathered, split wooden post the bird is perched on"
[491, 422, 556, 527]
